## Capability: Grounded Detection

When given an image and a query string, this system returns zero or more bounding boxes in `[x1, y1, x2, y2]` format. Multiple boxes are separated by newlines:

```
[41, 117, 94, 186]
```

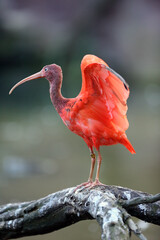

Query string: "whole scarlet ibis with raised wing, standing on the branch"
[9, 54, 135, 186]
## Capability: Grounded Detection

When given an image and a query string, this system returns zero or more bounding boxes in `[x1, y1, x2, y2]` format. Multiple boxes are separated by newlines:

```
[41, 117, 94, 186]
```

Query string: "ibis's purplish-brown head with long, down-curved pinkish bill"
[9, 64, 62, 94]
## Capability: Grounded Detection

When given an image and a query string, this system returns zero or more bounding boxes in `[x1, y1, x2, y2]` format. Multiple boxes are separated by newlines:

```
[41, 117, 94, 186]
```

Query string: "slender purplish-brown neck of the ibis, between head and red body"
[50, 78, 68, 114]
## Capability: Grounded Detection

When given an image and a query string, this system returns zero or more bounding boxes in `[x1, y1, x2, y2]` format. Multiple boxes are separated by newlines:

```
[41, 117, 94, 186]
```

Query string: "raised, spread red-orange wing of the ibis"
[80, 60, 129, 131]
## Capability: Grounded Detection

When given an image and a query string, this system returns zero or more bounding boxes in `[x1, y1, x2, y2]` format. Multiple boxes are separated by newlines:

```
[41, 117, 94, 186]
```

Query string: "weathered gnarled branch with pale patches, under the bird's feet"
[0, 186, 160, 240]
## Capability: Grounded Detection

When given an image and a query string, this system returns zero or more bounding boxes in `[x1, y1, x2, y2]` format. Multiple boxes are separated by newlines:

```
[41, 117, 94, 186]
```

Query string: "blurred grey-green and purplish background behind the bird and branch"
[0, 0, 160, 240]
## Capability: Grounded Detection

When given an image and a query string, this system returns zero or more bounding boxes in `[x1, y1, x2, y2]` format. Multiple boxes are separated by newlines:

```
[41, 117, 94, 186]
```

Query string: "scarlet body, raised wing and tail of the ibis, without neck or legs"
[62, 55, 135, 153]
